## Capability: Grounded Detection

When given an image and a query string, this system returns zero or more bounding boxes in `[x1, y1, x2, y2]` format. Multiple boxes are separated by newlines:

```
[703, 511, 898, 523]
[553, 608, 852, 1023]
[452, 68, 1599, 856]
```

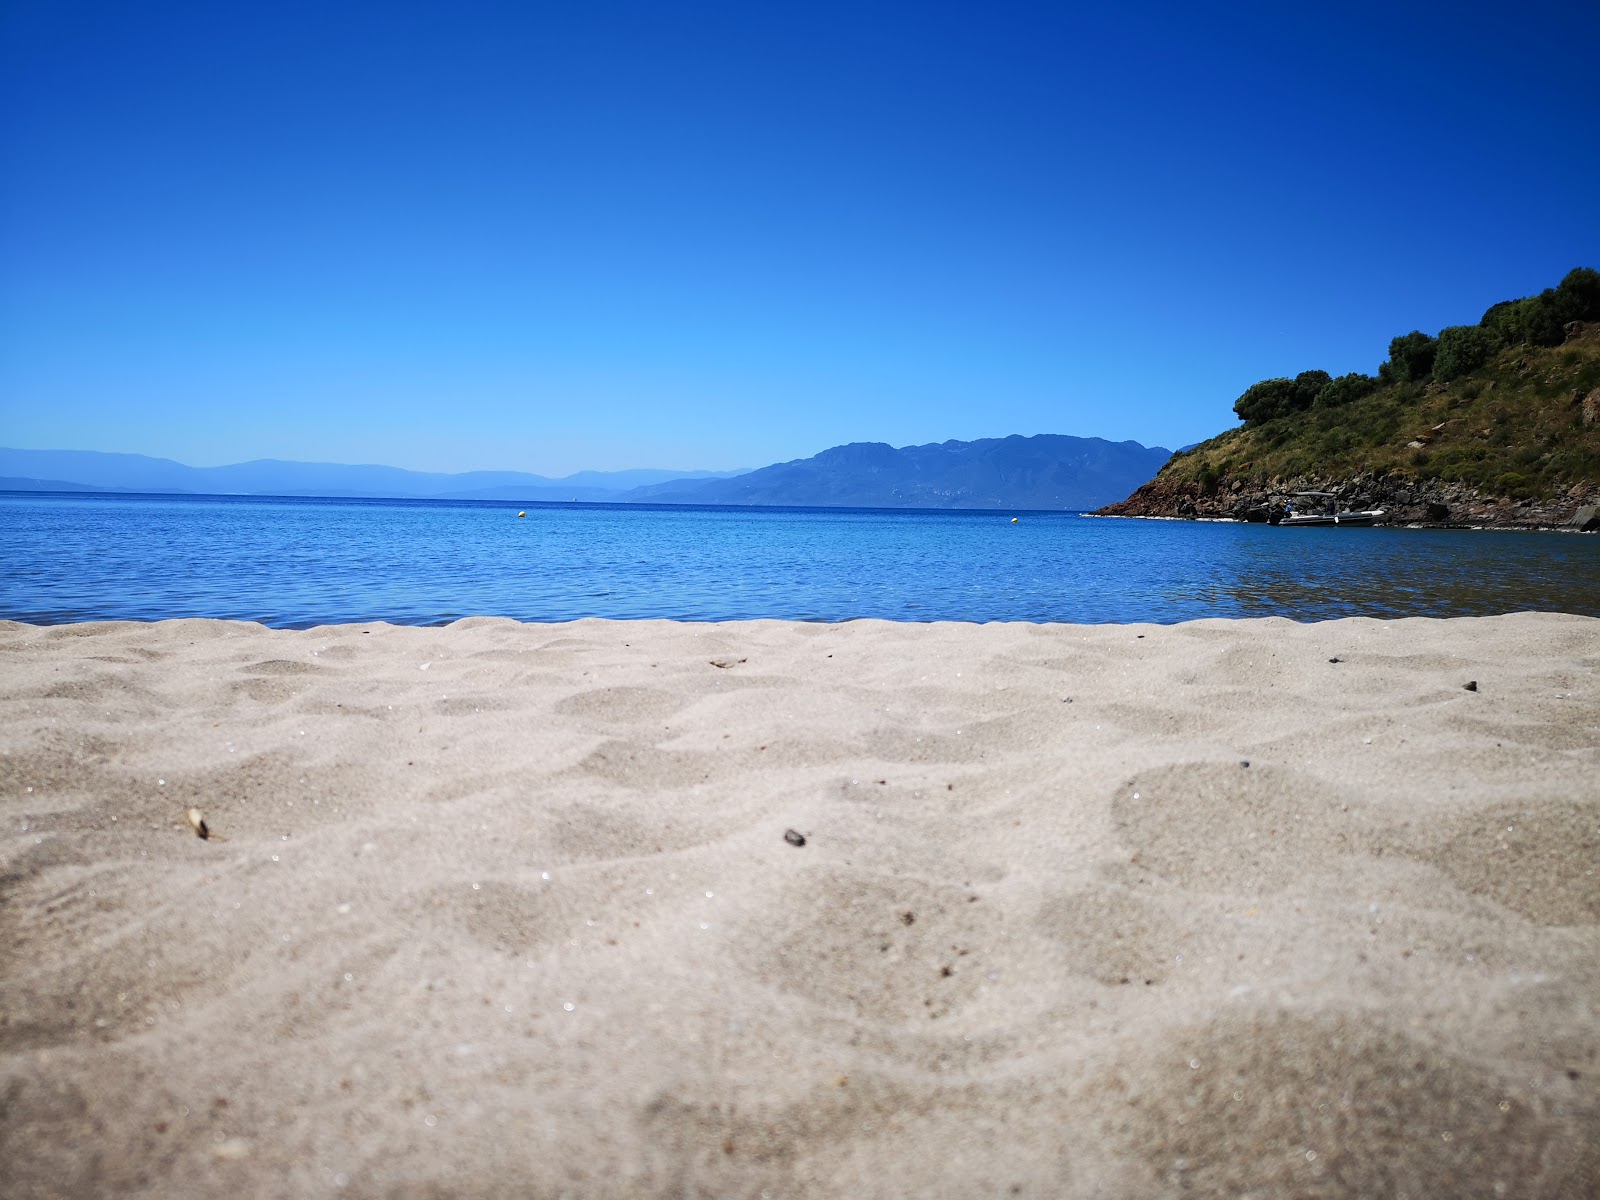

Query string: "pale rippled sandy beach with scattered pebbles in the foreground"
[0, 614, 1600, 1200]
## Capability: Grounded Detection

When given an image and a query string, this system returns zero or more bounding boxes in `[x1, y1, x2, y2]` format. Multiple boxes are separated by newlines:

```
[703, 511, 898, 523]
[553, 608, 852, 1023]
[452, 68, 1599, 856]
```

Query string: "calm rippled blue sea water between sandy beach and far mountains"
[0, 493, 1600, 629]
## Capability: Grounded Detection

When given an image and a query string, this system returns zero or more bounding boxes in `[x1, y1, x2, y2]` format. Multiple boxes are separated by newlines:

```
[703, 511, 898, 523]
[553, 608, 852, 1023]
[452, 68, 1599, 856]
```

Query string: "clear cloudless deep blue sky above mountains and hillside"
[0, 0, 1600, 475]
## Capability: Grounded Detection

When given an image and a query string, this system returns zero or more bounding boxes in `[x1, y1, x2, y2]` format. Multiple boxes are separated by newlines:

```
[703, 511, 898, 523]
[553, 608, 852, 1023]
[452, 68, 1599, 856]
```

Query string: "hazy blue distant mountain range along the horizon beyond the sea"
[0, 434, 1171, 512]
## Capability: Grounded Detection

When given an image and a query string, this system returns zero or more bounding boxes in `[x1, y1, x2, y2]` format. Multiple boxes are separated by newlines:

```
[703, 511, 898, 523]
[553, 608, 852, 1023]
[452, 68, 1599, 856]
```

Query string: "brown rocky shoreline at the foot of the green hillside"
[1094, 475, 1600, 533]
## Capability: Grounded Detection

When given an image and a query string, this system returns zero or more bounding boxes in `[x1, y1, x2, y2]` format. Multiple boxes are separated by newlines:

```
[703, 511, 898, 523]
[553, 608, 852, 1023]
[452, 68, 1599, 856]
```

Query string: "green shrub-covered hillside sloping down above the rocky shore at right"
[1107, 269, 1600, 518]
